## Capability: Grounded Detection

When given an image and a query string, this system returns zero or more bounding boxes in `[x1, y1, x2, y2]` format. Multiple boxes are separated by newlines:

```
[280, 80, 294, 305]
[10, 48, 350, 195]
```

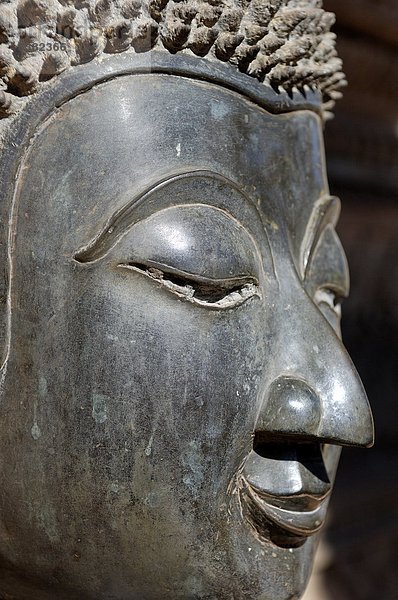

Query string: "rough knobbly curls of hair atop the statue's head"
[0, 0, 345, 124]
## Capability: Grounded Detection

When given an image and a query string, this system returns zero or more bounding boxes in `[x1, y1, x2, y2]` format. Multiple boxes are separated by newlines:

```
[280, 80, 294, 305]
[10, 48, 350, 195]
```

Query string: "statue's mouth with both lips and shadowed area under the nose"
[239, 442, 339, 546]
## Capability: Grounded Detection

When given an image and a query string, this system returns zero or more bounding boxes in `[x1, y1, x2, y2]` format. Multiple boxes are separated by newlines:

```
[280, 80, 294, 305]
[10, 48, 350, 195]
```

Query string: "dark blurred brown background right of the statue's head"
[306, 0, 398, 600]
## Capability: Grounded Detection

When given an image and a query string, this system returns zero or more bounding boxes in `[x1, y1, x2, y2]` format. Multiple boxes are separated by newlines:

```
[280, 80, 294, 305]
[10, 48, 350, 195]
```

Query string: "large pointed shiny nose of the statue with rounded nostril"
[256, 284, 373, 447]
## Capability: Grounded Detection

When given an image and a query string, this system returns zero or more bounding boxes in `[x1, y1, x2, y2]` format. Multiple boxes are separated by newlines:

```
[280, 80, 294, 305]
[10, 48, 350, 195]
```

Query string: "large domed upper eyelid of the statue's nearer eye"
[104, 204, 261, 289]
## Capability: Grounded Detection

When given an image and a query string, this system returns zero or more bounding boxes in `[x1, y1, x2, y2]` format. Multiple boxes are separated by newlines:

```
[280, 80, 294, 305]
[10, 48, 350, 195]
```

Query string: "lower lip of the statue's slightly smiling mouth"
[239, 478, 328, 538]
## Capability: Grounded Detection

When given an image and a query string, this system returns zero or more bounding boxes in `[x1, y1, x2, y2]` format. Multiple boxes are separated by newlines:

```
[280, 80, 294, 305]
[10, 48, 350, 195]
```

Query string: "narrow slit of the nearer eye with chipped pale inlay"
[118, 261, 259, 309]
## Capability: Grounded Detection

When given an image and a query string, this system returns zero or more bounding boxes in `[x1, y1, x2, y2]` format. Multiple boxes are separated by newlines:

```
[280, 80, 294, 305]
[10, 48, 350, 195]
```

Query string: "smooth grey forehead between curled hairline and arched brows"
[15, 74, 327, 252]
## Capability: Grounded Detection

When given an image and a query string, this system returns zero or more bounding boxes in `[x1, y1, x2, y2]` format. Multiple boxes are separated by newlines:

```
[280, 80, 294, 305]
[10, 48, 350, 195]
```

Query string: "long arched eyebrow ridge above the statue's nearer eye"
[73, 170, 264, 263]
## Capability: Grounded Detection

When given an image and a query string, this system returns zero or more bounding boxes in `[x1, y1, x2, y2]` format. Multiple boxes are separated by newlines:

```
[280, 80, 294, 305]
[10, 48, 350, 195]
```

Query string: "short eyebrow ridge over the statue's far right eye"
[300, 195, 340, 280]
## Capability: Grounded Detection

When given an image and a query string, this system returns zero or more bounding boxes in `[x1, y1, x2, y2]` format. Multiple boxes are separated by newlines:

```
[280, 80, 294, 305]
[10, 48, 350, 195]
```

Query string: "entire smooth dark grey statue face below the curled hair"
[0, 74, 372, 600]
